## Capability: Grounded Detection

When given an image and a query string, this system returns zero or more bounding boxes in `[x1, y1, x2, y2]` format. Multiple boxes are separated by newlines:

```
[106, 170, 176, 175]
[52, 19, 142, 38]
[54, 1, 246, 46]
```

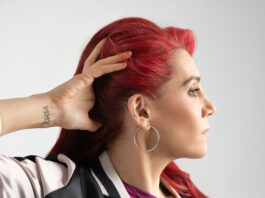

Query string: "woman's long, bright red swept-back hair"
[48, 17, 206, 198]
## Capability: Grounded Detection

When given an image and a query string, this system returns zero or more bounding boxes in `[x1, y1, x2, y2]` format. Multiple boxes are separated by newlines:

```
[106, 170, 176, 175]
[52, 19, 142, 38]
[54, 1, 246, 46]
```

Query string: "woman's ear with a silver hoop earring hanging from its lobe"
[127, 94, 151, 130]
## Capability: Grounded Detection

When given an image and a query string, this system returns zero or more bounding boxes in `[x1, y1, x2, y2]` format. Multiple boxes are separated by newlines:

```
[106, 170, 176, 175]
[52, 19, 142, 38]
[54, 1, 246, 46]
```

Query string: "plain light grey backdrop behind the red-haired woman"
[0, 0, 265, 198]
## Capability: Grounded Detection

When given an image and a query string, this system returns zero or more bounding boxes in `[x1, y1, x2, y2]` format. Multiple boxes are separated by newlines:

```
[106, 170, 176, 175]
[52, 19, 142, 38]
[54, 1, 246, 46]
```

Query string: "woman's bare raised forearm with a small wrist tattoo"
[0, 94, 57, 136]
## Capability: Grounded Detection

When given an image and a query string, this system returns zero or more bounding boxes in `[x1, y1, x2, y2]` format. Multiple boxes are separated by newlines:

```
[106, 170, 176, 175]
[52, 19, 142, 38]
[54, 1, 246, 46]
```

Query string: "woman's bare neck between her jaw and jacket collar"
[107, 142, 170, 197]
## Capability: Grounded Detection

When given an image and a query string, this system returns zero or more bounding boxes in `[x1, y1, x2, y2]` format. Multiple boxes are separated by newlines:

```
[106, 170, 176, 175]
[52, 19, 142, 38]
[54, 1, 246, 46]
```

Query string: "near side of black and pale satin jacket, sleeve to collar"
[0, 152, 129, 198]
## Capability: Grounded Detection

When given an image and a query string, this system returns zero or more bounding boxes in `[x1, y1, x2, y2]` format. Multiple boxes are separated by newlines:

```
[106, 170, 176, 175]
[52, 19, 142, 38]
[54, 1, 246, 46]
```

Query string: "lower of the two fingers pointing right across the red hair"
[89, 62, 127, 78]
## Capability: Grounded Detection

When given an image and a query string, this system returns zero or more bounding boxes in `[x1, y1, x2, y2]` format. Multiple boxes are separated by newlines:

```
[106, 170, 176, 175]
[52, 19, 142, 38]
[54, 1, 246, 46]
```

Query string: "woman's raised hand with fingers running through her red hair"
[46, 39, 131, 131]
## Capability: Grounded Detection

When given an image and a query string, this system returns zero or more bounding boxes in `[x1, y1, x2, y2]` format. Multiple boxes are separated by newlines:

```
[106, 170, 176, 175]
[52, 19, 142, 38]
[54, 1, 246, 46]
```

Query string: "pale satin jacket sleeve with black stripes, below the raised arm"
[0, 154, 80, 197]
